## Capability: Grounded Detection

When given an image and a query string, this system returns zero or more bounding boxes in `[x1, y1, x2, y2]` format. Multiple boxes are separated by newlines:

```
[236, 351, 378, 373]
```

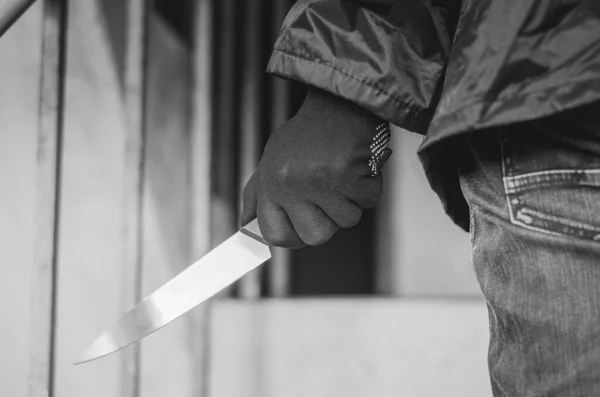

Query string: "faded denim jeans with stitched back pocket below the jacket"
[459, 110, 600, 397]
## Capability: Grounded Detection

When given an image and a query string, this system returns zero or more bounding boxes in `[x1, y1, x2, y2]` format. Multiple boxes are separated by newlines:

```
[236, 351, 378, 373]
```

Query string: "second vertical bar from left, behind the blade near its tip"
[121, 0, 147, 397]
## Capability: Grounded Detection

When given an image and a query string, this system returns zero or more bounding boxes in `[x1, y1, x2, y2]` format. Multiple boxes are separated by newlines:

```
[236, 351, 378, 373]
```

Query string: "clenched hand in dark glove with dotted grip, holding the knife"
[242, 88, 391, 248]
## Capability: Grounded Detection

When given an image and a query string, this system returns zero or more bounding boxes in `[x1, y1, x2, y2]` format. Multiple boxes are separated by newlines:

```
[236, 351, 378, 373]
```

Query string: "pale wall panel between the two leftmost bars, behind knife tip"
[55, 0, 134, 397]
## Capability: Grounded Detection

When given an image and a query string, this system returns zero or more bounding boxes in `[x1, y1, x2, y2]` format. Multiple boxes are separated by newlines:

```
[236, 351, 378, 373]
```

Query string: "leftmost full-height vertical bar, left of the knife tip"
[29, 0, 68, 397]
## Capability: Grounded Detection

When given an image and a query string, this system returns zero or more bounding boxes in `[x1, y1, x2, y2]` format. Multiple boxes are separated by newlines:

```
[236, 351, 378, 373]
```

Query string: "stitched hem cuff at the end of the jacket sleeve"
[267, 49, 432, 135]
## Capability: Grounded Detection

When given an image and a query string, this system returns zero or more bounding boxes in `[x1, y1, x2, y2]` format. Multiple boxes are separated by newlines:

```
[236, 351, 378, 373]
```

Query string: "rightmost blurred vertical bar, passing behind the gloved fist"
[268, 0, 291, 297]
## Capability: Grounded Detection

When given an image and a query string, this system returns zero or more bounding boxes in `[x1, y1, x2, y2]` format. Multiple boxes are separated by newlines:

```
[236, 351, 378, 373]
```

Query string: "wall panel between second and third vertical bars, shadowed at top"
[140, 16, 196, 397]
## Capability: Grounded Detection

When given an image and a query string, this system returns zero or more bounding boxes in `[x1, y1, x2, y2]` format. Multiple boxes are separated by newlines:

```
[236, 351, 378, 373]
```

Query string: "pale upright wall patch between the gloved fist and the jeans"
[377, 128, 481, 297]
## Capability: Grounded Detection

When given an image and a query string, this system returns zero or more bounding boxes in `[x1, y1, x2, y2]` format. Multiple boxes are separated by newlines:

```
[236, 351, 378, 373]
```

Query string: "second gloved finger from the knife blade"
[286, 203, 339, 246]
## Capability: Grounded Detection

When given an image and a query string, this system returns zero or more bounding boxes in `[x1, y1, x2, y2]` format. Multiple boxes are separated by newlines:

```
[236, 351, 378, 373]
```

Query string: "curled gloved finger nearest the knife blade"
[257, 199, 305, 248]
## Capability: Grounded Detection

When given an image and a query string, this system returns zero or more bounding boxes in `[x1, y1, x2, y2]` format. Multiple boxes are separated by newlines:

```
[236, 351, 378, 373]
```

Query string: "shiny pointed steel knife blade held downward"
[75, 219, 271, 364]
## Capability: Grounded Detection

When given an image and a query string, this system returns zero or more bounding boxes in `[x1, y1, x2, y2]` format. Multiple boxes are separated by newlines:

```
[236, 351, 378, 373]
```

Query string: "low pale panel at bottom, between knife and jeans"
[210, 299, 491, 397]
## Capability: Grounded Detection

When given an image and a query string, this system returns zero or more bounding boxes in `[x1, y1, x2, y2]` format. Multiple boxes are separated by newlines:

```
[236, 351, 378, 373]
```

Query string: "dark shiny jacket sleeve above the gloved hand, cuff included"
[267, 0, 460, 134]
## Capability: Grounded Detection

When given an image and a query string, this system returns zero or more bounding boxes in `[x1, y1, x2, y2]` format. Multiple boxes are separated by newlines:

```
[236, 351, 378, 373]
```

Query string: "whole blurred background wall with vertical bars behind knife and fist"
[0, 0, 490, 397]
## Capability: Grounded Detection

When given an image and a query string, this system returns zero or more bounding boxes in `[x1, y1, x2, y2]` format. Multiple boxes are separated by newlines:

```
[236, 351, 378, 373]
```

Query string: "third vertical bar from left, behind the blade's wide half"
[191, 0, 215, 397]
